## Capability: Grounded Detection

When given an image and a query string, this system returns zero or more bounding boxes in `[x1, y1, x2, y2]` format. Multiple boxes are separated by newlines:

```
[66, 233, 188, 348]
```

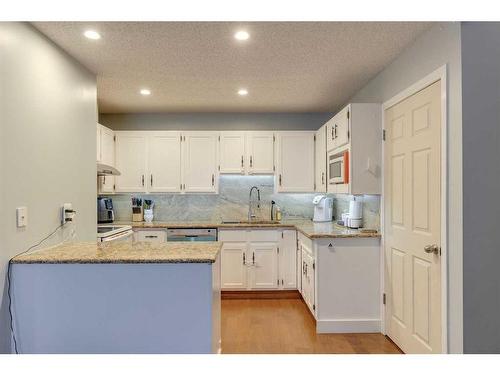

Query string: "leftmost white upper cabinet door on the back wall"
[115, 131, 147, 193]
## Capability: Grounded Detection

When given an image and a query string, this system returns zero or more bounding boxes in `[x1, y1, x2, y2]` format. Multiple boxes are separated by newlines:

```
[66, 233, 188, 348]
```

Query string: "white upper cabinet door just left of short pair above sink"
[182, 132, 219, 193]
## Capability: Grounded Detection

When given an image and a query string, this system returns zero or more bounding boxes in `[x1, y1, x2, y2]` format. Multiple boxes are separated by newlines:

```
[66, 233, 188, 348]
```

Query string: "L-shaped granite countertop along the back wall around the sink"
[114, 219, 380, 239]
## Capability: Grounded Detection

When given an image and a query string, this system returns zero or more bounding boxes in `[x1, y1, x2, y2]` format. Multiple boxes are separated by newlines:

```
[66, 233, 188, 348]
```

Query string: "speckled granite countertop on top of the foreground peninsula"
[11, 241, 222, 264]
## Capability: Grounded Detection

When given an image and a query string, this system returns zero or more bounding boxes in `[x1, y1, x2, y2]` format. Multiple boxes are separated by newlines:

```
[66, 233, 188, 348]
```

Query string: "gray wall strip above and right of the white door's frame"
[351, 23, 462, 353]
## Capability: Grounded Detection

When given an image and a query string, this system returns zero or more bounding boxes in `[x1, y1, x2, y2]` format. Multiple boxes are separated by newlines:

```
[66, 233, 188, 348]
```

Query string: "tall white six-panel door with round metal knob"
[384, 82, 442, 353]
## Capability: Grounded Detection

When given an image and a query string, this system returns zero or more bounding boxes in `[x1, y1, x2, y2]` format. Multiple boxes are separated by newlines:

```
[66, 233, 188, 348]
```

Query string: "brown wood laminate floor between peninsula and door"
[221, 299, 401, 354]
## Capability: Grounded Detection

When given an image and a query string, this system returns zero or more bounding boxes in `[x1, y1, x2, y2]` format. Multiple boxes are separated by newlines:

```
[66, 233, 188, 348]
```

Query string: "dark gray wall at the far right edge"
[462, 23, 500, 353]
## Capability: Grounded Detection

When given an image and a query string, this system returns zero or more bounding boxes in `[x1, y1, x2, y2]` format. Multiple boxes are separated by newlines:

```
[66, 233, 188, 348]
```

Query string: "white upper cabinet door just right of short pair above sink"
[275, 131, 315, 193]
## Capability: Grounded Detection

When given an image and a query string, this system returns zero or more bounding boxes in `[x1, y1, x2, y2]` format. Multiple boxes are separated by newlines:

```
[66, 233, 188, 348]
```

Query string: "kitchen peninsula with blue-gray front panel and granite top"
[11, 242, 222, 353]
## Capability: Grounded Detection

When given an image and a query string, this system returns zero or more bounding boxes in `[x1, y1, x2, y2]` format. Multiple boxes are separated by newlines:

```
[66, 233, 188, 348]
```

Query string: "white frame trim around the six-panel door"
[380, 64, 448, 353]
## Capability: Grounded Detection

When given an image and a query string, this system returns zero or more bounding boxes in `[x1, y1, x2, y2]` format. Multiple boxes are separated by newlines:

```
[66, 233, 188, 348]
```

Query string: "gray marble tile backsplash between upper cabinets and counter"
[108, 176, 380, 229]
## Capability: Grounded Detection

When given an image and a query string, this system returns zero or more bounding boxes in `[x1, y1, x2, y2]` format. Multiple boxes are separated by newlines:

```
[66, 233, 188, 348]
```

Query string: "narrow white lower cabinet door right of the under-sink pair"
[278, 230, 297, 289]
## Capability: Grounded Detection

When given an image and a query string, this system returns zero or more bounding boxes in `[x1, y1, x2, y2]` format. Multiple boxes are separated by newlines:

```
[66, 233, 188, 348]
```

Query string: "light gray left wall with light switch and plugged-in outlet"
[0, 22, 97, 353]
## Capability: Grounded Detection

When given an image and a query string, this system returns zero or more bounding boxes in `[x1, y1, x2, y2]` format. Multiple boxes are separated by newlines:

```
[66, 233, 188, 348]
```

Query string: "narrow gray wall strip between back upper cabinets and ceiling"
[99, 113, 333, 130]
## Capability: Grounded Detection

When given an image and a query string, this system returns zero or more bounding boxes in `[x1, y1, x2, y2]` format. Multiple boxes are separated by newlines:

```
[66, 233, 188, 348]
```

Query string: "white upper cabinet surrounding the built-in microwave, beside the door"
[326, 103, 382, 194]
